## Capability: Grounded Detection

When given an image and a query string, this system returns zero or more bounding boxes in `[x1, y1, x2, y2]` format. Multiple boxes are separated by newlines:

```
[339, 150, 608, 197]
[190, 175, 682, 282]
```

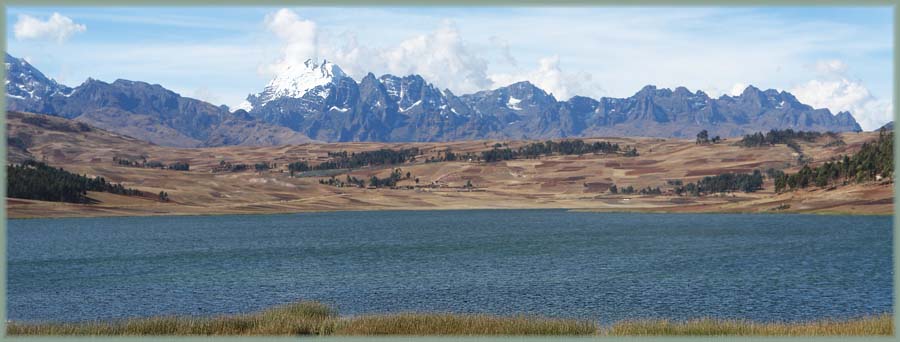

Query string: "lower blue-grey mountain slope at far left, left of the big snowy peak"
[6, 55, 310, 147]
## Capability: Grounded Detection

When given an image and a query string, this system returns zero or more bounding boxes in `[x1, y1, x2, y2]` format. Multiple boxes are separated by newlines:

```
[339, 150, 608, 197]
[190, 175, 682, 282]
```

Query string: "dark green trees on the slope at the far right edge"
[772, 130, 894, 192]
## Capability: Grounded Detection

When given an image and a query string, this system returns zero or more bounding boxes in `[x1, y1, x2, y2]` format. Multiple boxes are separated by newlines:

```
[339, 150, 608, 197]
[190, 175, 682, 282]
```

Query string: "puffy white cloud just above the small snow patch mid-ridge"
[491, 56, 602, 101]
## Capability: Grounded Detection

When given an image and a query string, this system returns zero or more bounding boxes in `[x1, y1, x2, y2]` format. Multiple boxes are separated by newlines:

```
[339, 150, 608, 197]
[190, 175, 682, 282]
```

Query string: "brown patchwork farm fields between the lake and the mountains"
[7, 113, 893, 218]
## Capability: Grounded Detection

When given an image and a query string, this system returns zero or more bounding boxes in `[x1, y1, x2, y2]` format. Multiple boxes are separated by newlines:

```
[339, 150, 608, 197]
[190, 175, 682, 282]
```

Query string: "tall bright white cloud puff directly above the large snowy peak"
[264, 8, 318, 72]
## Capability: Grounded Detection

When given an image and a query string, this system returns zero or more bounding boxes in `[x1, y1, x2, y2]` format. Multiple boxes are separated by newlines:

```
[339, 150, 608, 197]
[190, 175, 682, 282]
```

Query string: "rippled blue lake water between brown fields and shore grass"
[7, 210, 893, 323]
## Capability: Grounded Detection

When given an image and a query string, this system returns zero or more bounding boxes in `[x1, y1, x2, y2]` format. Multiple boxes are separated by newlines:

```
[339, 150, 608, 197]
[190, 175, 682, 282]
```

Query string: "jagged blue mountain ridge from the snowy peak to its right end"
[247, 61, 860, 141]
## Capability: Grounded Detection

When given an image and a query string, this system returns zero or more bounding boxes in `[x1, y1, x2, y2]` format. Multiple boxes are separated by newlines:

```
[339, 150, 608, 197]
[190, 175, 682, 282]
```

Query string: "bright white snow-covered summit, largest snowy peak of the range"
[259, 59, 347, 105]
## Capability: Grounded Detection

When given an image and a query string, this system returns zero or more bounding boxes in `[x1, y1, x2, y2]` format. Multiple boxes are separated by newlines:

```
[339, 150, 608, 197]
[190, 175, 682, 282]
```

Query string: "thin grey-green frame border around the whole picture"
[0, 0, 900, 341]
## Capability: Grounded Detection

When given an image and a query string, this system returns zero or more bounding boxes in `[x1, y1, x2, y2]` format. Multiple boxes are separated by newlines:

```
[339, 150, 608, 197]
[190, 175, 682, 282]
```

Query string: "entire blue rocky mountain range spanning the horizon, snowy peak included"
[6, 54, 861, 147]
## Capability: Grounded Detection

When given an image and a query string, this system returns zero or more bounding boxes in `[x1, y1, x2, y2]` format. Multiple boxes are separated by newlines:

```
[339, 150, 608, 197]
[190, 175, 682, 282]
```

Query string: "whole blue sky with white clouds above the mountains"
[6, 7, 894, 130]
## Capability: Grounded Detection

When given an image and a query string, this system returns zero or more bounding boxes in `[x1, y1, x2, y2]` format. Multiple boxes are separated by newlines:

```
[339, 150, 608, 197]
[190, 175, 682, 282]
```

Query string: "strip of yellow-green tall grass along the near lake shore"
[7, 302, 894, 336]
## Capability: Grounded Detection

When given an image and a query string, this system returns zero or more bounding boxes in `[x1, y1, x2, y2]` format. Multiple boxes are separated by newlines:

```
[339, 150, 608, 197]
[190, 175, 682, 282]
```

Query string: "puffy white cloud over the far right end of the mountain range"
[791, 60, 893, 131]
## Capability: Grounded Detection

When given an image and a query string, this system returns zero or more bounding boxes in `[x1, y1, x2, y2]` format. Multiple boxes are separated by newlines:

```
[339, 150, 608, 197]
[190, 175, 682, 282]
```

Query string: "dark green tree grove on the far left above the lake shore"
[6, 160, 145, 203]
